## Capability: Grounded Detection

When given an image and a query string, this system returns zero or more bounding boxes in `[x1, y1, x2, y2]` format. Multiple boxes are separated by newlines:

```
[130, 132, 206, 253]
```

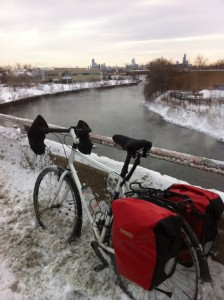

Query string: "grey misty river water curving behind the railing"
[1, 85, 224, 191]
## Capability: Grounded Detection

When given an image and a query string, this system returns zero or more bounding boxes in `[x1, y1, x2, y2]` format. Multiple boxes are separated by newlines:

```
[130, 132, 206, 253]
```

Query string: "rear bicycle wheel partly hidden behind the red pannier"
[108, 226, 199, 300]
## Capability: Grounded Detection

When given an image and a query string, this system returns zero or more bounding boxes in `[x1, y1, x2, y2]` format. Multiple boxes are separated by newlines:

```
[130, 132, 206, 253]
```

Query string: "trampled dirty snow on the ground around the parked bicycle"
[0, 127, 224, 300]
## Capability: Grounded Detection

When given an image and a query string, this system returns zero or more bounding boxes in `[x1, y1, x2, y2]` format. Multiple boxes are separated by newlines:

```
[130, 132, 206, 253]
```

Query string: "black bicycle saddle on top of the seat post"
[113, 134, 152, 151]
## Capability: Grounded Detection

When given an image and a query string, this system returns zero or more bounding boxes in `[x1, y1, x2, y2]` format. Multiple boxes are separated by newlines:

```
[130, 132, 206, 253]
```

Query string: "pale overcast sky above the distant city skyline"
[0, 0, 224, 67]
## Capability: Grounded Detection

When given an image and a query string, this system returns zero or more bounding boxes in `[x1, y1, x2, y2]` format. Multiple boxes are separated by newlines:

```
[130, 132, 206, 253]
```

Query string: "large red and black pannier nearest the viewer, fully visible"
[112, 198, 182, 290]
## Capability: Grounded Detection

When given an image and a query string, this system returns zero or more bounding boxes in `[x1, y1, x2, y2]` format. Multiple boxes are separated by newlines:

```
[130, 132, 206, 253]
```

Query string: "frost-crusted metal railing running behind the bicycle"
[0, 114, 224, 175]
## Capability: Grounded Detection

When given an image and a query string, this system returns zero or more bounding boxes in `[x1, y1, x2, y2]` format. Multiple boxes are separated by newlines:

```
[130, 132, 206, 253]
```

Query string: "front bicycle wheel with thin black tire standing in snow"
[33, 166, 82, 242]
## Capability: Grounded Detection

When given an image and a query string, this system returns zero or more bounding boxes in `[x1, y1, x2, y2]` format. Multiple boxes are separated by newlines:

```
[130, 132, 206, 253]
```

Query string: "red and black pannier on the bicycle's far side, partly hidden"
[167, 184, 224, 255]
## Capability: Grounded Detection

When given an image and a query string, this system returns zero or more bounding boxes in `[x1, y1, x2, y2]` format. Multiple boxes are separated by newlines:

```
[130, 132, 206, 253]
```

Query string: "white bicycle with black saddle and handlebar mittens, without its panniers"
[28, 116, 211, 299]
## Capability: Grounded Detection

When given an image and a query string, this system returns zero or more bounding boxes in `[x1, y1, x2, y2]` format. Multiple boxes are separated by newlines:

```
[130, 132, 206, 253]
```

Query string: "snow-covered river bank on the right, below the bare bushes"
[143, 90, 224, 141]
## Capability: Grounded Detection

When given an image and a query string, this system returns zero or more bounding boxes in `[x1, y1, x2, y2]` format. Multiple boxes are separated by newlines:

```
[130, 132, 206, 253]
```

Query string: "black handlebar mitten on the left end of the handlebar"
[27, 115, 48, 155]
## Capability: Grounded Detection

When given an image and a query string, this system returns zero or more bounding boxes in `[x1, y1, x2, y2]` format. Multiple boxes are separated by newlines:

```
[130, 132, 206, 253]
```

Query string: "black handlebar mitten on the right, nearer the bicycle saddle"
[75, 120, 93, 154]
